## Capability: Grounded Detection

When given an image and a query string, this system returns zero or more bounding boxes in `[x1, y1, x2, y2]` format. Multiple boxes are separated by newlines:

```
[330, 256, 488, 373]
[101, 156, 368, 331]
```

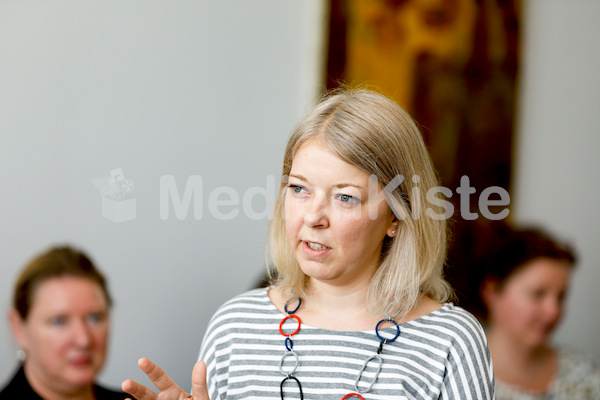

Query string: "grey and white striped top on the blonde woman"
[200, 288, 494, 400]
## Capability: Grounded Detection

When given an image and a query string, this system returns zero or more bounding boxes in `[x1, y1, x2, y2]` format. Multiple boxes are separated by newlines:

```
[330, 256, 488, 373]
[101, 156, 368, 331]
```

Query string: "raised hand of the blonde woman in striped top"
[121, 358, 210, 400]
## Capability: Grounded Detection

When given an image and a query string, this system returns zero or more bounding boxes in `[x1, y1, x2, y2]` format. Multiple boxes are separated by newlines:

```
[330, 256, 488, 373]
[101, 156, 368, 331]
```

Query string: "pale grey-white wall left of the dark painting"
[0, 0, 325, 387]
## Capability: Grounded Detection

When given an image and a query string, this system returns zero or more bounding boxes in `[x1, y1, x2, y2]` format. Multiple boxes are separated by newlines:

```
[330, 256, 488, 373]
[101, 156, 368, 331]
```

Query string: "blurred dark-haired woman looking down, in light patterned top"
[480, 229, 600, 400]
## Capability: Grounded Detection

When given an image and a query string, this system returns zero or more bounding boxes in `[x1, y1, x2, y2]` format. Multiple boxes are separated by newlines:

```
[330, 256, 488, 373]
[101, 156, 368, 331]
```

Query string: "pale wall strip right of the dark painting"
[513, 0, 600, 357]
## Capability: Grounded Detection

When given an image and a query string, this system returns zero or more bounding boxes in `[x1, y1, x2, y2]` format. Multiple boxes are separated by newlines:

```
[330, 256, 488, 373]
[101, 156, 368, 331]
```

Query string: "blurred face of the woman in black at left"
[17, 277, 109, 391]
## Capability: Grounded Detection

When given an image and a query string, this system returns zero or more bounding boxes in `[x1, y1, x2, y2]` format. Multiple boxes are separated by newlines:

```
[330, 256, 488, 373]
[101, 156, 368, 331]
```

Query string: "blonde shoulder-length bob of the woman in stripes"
[268, 89, 453, 316]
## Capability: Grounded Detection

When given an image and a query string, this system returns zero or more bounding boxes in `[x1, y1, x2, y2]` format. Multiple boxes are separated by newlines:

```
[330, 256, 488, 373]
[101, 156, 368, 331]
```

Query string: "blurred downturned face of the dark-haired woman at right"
[485, 258, 571, 348]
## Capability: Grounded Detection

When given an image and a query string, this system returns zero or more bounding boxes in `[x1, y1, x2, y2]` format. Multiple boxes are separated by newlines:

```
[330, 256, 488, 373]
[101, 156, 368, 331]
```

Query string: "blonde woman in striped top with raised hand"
[123, 90, 494, 400]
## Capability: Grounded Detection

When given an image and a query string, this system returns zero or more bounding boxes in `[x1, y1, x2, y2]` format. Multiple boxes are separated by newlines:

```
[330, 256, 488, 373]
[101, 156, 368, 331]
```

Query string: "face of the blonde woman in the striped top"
[285, 141, 398, 286]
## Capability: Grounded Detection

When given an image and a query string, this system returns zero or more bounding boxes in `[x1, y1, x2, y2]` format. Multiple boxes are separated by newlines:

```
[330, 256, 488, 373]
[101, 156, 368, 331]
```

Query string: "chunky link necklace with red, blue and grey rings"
[279, 297, 400, 400]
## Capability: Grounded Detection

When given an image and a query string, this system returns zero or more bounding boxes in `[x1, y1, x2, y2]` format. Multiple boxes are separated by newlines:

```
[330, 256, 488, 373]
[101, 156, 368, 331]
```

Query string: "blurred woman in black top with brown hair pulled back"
[0, 247, 125, 400]
